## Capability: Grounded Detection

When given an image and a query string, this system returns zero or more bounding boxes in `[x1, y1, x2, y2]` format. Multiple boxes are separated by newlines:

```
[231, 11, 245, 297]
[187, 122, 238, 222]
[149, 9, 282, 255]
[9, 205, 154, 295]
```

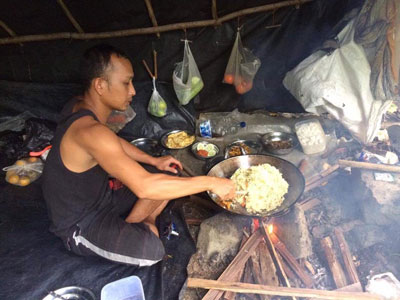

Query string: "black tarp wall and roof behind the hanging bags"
[0, 0, 364, 112]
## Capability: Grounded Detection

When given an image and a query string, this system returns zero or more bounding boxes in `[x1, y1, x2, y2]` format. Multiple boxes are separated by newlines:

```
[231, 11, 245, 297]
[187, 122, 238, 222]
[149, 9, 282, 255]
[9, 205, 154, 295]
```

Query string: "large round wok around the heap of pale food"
[207, 155, 305, 217]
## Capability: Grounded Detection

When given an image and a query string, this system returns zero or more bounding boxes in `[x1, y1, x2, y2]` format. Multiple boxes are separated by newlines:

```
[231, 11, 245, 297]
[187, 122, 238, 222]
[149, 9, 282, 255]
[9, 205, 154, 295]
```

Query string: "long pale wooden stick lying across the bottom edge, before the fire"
[187, 278, 381, 300]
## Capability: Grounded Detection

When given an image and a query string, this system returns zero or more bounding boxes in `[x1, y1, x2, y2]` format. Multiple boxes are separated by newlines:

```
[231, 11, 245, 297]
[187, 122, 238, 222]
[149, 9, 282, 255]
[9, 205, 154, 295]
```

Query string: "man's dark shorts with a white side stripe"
[63, 187, 165, 267]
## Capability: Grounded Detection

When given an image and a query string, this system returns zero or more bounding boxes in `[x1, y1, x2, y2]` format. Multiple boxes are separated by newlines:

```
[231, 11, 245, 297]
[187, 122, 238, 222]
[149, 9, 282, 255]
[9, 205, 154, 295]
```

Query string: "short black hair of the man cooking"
[81, 44, 129, 92]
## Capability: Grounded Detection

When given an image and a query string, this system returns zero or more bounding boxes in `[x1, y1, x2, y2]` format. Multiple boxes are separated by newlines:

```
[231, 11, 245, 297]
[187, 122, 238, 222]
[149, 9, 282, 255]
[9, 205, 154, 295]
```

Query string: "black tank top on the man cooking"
[42, 110, 111, 236]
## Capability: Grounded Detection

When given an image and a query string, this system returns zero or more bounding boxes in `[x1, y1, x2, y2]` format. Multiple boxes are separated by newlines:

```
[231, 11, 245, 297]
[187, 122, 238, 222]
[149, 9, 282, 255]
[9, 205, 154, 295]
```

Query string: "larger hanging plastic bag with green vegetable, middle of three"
[172, 40, 204, 105]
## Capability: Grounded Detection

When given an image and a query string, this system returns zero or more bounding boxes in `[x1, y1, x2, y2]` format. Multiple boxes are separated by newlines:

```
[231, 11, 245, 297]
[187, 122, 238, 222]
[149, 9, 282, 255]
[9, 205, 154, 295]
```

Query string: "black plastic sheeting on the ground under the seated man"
[0, 177, 195, 300]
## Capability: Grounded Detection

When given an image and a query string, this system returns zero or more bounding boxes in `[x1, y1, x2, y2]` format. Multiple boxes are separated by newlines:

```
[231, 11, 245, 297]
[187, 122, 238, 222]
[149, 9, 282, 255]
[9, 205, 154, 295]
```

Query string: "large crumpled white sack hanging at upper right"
[283, 20, 392, 144]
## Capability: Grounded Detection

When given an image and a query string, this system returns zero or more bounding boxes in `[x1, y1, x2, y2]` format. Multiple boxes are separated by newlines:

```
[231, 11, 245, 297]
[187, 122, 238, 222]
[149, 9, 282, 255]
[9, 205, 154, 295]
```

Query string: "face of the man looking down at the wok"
[102, 54, 136, 111]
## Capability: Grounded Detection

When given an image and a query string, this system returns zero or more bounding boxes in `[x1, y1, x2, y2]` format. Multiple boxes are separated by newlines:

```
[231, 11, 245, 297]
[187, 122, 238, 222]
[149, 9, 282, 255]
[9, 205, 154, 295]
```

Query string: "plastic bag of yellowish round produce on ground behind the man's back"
[3, 157, 43, 186]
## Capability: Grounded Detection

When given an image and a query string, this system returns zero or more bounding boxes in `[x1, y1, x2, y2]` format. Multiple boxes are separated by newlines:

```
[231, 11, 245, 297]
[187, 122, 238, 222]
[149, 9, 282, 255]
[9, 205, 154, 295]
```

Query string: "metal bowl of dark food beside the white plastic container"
[261, 131, 298, 155]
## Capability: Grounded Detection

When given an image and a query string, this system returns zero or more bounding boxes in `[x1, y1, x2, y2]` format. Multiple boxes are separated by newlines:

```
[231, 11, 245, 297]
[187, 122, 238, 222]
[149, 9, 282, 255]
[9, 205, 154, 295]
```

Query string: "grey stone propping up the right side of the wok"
[274, 204, 312, 259]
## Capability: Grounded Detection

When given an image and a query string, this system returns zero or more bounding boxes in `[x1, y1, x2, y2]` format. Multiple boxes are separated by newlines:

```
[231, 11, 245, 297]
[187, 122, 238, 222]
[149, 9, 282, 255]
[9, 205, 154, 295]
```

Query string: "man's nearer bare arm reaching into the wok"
[77, 124, 235, 200]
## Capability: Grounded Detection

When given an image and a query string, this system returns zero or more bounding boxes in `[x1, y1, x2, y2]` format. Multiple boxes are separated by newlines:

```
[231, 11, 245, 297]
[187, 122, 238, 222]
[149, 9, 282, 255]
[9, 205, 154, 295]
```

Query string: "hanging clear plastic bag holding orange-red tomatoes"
[223, 31, 261, 94]
